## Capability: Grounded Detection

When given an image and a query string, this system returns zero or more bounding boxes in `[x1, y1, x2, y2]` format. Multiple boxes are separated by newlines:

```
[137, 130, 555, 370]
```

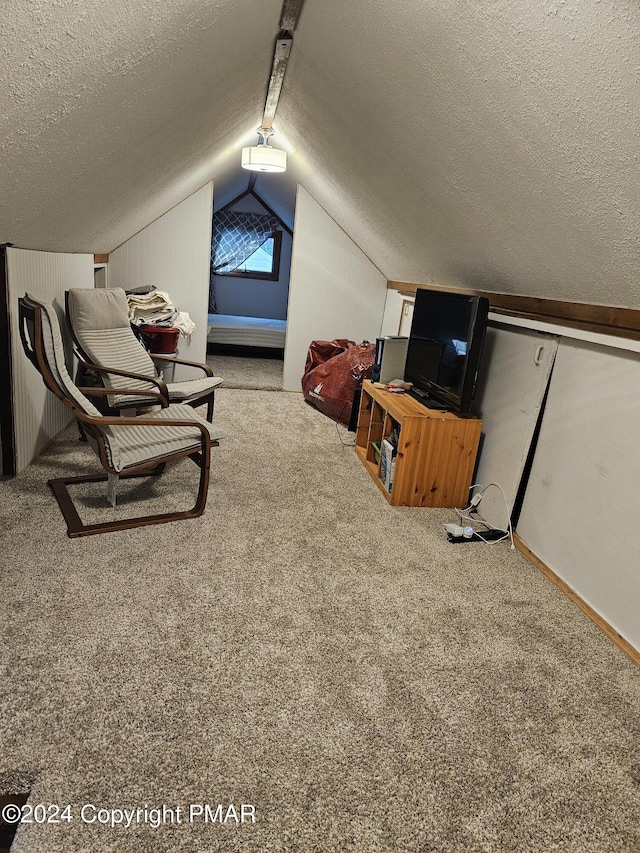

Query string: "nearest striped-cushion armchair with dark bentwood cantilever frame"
[18, 294, 224, 538]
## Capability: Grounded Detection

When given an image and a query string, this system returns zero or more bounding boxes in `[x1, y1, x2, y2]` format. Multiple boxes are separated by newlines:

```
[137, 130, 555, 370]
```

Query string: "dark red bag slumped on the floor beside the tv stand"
[302, 338, 376, 426]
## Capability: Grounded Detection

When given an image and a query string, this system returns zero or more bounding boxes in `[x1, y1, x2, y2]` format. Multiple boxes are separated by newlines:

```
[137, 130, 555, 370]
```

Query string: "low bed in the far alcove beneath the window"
[207, 314, 287, 358]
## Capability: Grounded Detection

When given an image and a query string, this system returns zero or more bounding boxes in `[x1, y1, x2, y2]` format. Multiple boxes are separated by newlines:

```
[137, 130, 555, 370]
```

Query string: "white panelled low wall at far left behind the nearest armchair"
[7, 249, 93, 474]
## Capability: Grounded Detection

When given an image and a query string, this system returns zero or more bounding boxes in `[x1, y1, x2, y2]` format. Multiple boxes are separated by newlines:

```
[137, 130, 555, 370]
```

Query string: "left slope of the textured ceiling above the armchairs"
[0, 0, 282, 252]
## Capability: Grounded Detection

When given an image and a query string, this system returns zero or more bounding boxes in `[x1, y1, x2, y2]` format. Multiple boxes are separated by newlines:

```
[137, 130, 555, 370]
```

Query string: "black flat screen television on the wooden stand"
[404, 289, 489, 413]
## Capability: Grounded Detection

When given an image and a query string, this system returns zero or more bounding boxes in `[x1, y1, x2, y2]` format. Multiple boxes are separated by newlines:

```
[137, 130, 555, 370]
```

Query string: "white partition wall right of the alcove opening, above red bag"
[283, 186, 387, 391]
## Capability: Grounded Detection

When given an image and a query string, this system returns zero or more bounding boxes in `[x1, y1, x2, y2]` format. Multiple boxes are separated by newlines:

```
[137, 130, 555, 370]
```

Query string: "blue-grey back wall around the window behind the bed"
[213, 196, 293, 320]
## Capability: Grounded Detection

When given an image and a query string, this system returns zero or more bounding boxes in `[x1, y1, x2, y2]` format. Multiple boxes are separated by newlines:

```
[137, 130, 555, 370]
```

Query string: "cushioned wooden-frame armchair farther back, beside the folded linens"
[65, 287, 223, 421]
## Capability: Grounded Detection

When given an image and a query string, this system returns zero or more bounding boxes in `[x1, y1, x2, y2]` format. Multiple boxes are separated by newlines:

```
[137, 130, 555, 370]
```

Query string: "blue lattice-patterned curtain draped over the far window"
[209, 210, 280, 314]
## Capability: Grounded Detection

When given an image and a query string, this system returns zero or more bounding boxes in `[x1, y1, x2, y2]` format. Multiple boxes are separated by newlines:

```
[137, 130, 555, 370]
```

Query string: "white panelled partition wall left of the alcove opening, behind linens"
[108, 182, 213, 379]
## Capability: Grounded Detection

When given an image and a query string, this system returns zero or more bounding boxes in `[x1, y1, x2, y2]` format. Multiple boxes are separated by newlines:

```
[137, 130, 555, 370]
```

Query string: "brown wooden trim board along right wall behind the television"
[387, 281, 640, 340]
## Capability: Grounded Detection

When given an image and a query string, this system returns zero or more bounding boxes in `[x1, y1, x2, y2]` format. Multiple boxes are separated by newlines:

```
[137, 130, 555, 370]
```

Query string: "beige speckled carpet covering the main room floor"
[0, 389, 640, 853]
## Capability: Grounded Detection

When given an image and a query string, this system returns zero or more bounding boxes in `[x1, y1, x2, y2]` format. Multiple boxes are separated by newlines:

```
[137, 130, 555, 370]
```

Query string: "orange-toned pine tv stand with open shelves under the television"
[356, 380, 482, 507]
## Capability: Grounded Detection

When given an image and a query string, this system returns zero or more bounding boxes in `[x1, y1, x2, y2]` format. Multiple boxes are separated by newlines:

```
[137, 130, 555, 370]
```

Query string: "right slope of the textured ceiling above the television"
[279, 0, 640, 307]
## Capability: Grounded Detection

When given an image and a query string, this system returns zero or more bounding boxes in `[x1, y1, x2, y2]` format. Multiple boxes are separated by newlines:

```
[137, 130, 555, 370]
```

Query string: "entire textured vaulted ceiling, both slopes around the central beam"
[0, 0, 640, 308]
